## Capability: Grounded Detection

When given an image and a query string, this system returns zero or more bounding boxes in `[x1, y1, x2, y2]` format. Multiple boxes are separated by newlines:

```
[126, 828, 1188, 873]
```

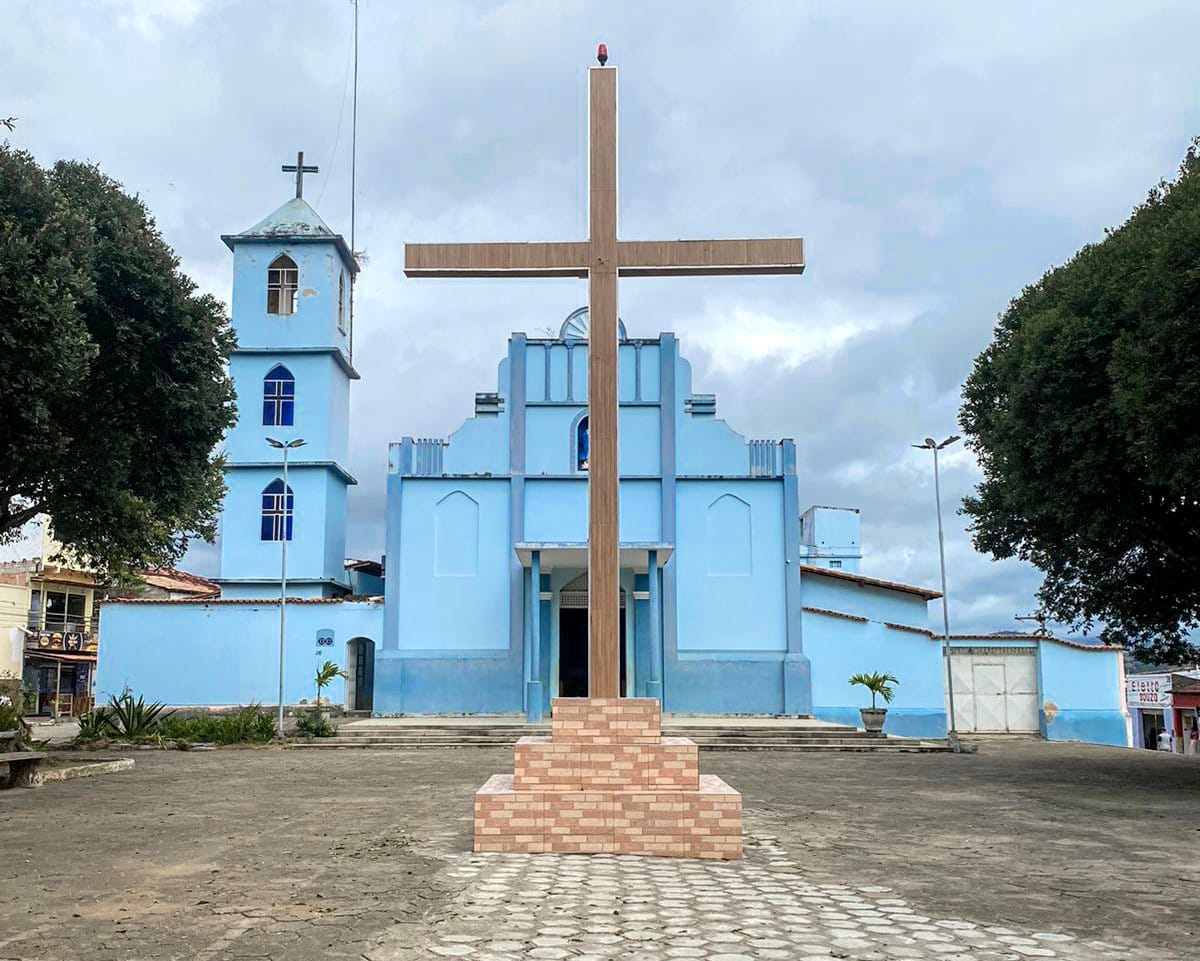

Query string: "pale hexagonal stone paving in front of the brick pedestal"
[381, 837, 1150, 961]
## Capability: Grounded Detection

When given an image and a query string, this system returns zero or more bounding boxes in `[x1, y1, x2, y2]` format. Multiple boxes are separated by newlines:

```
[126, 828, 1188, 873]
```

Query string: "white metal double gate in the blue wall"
[950, 647, 1040, 734]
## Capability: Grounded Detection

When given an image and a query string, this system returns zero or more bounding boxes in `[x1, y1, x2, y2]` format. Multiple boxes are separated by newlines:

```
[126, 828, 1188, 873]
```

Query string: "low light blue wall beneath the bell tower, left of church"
[96, 600, 383, 707]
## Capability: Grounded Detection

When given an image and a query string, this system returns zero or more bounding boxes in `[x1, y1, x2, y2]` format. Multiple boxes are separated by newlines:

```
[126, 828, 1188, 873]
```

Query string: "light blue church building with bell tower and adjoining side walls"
[97, 198, 1128, 744]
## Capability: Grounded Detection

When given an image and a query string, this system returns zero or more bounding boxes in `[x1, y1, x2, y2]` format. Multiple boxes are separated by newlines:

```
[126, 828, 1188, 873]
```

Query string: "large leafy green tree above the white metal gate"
[960, 139, 1200, 662]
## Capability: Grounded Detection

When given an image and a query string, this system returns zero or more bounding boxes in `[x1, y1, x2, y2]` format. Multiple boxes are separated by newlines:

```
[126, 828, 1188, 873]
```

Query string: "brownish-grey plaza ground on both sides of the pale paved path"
[0, 741, 1200, 961]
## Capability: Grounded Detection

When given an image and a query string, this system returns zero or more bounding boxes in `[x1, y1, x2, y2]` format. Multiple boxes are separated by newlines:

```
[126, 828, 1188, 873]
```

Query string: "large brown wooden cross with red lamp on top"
[404, 49, 804, 697]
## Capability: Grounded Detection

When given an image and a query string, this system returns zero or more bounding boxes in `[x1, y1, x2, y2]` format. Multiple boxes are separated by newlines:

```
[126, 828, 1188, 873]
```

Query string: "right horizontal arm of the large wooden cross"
[617, 238, 804, 277]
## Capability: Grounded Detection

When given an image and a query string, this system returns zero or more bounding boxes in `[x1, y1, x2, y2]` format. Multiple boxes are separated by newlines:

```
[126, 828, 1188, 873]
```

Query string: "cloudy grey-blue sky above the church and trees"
[9, 0, 1200, 630]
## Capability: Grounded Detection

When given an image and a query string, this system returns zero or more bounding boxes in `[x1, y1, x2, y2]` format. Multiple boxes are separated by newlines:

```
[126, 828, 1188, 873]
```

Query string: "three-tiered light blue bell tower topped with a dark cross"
[217, 154, 359, 597]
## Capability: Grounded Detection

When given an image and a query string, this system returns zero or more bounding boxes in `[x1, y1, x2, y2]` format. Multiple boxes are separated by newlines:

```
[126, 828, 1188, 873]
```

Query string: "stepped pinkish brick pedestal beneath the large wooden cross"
[475, 697, 742, 860]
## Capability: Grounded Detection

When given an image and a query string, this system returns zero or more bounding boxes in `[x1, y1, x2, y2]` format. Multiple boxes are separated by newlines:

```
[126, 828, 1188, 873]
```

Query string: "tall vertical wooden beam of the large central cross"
[588, 67, 620, 697]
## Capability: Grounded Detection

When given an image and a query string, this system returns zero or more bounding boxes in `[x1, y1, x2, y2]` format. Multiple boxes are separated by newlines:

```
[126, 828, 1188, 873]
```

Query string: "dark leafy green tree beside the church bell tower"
[0, 144, 234, 573]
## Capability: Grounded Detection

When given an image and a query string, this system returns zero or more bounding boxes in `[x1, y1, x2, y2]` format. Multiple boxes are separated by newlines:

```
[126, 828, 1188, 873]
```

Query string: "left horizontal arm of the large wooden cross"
[404, 241, 589, 277]
